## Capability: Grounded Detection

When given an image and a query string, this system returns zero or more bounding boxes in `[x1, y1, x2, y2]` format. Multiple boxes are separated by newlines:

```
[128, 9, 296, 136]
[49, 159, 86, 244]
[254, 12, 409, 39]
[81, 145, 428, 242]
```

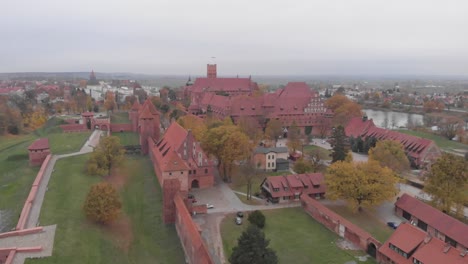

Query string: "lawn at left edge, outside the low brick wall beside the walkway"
[0, 135, 39, 232]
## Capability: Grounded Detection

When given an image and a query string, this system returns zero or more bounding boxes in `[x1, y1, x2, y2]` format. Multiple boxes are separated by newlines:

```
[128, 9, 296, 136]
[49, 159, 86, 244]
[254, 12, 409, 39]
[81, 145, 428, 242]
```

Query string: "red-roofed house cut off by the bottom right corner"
[377, 223, 468, 264]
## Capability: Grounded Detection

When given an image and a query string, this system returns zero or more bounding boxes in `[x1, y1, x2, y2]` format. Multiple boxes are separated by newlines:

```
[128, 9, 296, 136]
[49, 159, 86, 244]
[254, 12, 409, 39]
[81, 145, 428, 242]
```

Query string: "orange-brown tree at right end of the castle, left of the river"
[325, 93, 362, 126]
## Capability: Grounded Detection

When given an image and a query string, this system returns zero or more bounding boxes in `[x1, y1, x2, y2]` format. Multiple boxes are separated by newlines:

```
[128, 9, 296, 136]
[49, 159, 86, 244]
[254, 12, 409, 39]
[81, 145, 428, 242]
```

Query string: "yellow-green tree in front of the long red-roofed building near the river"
[369, 140, 410, 173]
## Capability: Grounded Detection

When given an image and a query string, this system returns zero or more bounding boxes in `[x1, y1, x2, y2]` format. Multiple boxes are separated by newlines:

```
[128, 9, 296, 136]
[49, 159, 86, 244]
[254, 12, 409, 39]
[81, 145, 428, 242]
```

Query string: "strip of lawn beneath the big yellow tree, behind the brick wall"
[324, 204, 393, 243]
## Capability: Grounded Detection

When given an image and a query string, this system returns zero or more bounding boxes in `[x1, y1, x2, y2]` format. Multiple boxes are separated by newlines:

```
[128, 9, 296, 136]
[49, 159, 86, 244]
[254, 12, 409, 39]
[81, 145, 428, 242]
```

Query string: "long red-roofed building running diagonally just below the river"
[345, 117, 441, 168]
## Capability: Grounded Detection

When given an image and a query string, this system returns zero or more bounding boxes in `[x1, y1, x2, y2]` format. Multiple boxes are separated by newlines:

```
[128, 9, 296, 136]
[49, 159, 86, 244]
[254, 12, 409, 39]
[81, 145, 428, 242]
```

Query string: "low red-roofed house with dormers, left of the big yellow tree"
[260, 173, 326, 203]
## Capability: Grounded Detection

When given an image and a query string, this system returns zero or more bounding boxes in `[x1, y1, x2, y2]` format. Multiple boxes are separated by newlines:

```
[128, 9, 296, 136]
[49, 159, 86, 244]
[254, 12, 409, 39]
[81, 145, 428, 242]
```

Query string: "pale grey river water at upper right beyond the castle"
[363, 109, 423, 129]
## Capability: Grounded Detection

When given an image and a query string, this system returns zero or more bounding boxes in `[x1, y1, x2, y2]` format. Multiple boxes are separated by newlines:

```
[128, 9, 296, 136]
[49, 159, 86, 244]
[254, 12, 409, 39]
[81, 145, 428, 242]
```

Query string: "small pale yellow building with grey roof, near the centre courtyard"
[253, 147, 289, 171]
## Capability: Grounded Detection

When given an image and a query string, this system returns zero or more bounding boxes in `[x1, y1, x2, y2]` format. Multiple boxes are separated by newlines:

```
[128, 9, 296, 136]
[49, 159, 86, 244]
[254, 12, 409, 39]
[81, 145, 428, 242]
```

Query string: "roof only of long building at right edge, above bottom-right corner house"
[395, 194, 468, 248]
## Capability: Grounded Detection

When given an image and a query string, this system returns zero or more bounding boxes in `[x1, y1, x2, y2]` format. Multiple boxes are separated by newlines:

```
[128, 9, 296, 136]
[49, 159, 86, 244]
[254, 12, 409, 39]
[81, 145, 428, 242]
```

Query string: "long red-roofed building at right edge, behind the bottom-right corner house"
[395, 194, 468, 251]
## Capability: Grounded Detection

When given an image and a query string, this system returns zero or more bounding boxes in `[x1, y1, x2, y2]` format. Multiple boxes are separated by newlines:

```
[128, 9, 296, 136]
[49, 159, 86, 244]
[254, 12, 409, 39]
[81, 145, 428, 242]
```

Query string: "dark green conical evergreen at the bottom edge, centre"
[229, 225, 278, 264]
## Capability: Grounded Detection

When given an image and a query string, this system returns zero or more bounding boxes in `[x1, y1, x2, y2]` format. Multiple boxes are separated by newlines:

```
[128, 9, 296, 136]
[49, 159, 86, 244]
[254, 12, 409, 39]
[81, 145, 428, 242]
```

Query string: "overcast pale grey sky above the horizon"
[0, 0, 468, 75]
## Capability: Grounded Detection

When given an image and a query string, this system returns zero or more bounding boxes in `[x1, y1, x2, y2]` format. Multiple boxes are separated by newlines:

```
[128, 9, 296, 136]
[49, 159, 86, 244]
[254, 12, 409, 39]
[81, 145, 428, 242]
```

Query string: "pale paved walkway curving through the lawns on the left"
[0, 130, 102, 264]
